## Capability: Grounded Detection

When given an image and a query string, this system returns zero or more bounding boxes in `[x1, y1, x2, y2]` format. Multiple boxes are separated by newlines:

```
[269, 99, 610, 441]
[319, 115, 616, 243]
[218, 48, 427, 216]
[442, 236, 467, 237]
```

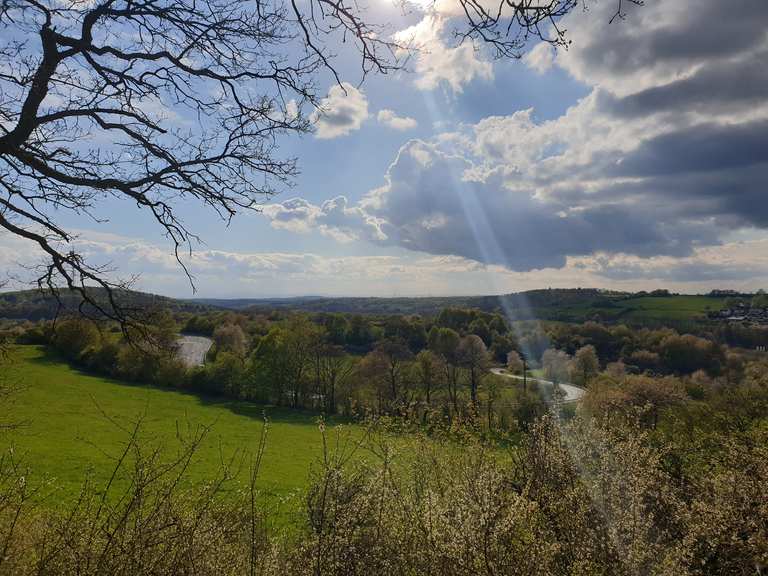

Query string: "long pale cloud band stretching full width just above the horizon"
[6, 225, 768, 297]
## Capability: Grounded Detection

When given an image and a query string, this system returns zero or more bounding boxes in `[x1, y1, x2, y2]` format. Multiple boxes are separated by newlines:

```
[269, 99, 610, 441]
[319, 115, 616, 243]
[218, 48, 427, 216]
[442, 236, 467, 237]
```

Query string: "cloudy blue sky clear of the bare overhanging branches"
[0, 0, 768, 298]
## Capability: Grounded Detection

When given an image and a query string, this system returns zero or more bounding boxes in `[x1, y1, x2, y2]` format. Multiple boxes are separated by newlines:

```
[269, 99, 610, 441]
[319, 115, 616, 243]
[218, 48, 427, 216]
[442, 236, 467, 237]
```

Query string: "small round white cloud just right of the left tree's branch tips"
[310, 82, 368, 139]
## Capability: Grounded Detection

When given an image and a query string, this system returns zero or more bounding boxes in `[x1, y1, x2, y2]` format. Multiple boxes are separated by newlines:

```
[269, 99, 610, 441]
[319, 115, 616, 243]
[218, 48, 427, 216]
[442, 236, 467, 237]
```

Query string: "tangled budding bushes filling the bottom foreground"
[0, 417, 768, 576]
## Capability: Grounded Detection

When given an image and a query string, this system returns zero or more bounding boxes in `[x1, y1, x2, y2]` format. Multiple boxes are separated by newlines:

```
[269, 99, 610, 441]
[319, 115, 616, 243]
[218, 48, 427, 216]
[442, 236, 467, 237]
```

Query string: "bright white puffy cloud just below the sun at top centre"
[395, 13, 493, 93]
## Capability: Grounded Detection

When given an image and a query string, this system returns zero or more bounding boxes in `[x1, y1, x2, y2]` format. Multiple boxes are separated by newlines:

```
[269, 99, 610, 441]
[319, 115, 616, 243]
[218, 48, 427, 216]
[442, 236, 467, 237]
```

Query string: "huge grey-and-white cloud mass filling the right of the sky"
[262, 0, 768, 281]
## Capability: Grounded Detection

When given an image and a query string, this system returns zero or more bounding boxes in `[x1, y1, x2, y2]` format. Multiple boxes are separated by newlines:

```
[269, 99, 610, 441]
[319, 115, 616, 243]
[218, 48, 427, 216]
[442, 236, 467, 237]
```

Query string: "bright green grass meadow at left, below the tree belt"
[3, 346, 357, 512]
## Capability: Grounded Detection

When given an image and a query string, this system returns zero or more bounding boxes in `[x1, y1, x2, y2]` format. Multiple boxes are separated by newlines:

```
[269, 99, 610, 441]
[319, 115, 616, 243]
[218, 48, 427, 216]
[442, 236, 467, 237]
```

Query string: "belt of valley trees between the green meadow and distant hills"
[7, 308, 760, 429]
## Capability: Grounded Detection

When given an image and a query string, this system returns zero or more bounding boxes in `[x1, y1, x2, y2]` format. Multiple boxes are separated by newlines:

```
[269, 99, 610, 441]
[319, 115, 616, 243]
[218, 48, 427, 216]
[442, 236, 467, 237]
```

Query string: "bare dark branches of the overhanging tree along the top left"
[0, 0, 632, 321]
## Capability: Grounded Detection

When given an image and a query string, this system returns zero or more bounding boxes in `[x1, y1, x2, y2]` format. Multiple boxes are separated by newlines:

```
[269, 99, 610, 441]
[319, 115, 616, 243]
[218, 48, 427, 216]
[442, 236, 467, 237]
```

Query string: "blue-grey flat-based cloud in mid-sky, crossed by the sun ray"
[362, 142, 713, 271]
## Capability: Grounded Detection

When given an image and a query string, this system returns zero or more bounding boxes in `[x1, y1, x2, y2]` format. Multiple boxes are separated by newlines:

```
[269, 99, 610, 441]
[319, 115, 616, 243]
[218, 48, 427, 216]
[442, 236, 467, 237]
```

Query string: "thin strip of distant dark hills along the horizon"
[0, 288, 728, 326]
